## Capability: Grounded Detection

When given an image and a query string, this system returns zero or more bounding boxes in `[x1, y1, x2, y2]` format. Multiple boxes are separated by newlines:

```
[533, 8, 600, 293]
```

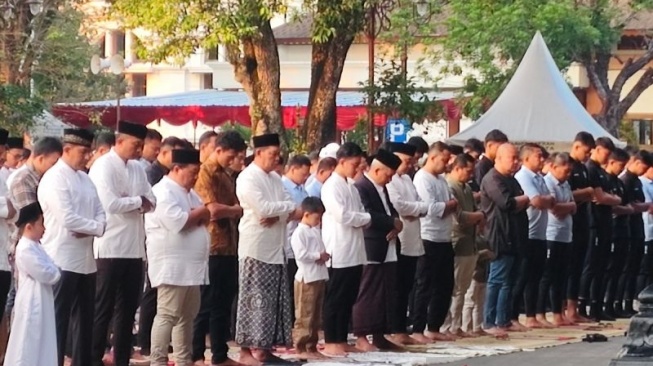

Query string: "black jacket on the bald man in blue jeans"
[480, 168, 528, 255]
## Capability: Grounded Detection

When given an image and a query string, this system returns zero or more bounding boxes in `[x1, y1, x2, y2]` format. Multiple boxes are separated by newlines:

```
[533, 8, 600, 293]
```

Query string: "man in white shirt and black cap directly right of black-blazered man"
[386, 142, 429, 344]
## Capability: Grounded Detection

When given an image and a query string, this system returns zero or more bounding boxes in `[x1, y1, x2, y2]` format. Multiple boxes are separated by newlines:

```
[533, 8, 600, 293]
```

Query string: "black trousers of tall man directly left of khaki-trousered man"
[92, 258, 143, 366]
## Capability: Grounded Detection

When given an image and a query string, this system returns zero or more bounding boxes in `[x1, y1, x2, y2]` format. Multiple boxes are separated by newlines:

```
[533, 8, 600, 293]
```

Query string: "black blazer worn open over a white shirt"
[355, 176, 399, 263]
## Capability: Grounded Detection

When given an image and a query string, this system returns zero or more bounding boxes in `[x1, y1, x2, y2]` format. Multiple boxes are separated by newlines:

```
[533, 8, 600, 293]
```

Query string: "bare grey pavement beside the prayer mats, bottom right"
[446, 337, 625, 366]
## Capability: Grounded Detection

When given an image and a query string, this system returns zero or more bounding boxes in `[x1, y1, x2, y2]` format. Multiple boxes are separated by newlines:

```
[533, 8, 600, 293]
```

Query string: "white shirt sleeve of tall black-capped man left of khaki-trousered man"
[88, 163, 142, 215]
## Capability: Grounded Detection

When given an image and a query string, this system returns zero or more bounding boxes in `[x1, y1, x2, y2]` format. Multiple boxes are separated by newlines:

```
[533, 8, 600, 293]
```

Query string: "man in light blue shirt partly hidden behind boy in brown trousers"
[281, 155, 311, 323]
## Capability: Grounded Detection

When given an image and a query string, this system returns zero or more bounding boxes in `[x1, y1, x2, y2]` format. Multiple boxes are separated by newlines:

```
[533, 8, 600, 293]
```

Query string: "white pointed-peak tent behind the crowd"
[449, 32, 625, 146]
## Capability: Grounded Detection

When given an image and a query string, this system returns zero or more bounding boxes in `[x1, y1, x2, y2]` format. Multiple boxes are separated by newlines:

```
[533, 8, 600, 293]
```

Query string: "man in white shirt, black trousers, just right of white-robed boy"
[38, 129, 106, 366]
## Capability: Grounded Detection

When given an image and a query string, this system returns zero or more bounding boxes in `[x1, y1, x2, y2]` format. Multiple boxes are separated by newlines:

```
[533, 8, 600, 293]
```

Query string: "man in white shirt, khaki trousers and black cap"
[145, 149, 210, 366]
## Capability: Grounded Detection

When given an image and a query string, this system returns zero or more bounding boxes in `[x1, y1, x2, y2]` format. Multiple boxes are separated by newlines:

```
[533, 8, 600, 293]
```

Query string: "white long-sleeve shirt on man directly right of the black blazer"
[386, 174, 429, 257]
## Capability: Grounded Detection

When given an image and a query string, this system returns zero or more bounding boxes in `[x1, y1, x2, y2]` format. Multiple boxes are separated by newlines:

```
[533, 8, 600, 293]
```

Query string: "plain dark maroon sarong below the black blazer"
[352, 262, 397, 336]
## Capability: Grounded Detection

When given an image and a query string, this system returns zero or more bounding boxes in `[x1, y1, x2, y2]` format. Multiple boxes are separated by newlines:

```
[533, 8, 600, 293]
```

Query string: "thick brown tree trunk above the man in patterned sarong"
[228, 22, 288, 151]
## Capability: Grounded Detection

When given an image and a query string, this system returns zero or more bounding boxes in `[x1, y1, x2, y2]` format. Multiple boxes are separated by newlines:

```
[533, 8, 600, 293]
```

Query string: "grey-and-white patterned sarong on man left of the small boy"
[235, 258, 292, 349]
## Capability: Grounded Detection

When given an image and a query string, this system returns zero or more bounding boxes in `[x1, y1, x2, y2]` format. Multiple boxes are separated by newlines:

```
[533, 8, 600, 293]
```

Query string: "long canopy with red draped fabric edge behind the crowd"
[52, 89, 459, 131]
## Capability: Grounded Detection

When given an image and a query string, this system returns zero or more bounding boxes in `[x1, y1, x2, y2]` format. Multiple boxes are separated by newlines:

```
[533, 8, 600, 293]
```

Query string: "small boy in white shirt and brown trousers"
[290, 197, 329, 358]
